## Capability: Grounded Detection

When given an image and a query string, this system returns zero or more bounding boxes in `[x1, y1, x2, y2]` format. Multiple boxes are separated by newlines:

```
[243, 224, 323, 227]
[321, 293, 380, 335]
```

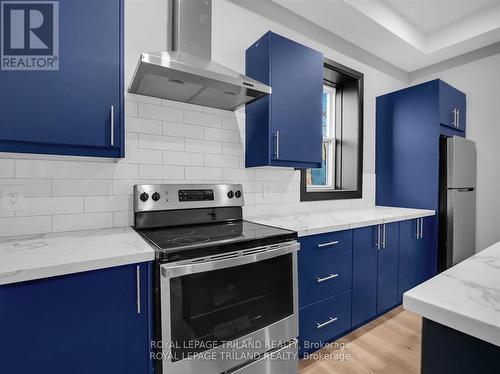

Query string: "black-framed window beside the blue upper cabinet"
[300, 60, 363, 201]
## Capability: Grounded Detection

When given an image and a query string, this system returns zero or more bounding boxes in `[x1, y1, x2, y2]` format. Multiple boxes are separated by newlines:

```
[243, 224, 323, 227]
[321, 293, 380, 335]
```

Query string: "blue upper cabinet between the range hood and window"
[246, 32, 323, 168]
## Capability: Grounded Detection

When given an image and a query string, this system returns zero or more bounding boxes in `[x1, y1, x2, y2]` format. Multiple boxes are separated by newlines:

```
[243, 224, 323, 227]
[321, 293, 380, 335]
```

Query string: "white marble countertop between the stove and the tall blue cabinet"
[249, 206, 435, 236]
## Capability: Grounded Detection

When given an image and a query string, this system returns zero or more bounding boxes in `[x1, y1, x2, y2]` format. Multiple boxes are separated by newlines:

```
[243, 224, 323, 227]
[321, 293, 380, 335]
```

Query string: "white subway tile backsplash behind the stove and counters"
[0, 98, 375, 236]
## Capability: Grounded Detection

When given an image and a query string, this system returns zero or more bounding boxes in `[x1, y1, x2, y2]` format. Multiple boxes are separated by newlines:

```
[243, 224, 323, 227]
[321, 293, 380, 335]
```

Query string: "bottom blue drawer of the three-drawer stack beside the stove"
[299, 291, 351, 353]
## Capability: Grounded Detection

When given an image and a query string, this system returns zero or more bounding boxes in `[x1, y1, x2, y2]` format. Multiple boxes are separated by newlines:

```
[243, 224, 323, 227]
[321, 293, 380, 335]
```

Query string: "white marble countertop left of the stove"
[0, 227, 154, 285]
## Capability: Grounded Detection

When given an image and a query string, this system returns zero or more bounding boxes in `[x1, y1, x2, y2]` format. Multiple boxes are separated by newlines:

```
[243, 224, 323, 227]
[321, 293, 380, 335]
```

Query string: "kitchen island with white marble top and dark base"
[403, 242, 500, 374]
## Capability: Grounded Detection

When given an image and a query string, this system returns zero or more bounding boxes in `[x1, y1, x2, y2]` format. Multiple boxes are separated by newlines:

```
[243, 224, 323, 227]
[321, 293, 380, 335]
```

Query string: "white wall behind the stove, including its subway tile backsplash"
[0, 0, 405, 236]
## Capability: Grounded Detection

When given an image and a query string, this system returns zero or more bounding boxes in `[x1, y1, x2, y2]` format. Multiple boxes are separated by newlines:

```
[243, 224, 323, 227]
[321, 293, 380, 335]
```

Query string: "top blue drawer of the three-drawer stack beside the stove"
[299, 230, 352, 258]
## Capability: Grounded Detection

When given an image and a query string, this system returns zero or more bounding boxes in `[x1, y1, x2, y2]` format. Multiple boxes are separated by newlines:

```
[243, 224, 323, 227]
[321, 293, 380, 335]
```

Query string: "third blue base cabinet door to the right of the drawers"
[398, 218, 420, 303]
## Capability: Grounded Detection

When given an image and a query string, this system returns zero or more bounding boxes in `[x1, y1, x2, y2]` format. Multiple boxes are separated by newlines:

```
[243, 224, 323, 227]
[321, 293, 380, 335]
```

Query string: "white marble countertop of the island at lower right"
[403, 242, 500, 346]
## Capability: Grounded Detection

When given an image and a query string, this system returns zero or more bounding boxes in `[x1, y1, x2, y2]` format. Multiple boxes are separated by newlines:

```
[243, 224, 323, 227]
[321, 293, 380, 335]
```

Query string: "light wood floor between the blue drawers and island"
[299, 307, 422, 374]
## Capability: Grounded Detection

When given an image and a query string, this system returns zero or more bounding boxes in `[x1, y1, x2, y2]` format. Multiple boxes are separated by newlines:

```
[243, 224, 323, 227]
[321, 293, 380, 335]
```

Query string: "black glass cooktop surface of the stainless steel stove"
[138, 220, 297, 260]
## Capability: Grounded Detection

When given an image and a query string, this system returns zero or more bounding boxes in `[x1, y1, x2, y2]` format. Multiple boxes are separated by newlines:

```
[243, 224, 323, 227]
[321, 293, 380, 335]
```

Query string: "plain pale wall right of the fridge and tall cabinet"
[413, 54, 500, 251]
